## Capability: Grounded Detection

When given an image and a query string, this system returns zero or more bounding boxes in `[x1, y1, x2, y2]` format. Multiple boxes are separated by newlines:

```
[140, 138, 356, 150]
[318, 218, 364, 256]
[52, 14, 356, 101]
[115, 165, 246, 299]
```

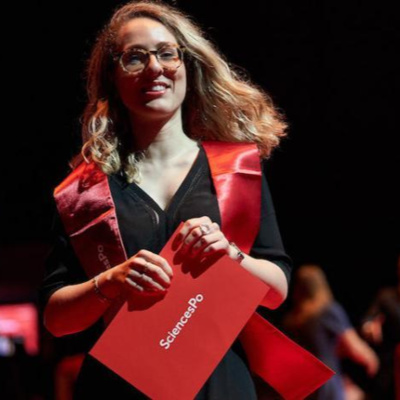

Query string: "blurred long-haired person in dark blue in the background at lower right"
[284, 265, 378, 400]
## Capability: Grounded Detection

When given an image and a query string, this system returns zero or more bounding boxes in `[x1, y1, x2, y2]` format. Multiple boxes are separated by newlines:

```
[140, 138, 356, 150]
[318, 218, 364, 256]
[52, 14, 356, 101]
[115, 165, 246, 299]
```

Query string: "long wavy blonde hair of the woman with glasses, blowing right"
[81, 0, 286, 182]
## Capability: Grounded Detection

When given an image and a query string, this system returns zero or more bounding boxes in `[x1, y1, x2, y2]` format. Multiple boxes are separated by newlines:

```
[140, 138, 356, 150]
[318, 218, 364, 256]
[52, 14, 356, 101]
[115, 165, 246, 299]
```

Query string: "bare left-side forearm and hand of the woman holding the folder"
[44, 250, 173, 336]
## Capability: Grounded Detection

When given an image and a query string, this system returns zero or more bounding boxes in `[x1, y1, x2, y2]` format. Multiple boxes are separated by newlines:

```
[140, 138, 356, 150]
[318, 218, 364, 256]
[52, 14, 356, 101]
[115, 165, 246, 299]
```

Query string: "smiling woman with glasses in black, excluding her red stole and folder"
[41, 2, 290, 399]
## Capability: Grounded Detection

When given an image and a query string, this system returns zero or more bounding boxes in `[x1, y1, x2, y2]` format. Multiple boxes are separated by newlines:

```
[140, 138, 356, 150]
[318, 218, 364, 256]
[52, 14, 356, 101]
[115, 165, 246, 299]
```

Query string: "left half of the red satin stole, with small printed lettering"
[54, 163, 127, 325]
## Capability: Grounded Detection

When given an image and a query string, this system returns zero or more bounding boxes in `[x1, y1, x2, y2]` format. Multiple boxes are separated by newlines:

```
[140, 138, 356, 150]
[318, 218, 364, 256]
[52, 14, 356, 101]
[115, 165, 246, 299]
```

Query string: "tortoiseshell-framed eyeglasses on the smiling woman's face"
[114, 43, 185, 74]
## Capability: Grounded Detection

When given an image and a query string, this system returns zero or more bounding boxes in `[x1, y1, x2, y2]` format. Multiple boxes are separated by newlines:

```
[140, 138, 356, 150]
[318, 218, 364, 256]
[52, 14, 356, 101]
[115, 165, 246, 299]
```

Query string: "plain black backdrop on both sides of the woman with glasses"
[0, 0, 400, 350]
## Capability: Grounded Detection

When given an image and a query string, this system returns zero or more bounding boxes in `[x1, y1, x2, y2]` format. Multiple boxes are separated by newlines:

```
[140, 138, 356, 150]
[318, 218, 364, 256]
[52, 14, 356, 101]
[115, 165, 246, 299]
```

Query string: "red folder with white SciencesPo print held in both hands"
[90, 223, 269, 400]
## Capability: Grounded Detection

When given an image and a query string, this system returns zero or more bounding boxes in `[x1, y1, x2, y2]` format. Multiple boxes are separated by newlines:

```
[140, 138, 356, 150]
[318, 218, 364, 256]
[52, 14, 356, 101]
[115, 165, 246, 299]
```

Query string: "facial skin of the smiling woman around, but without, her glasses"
[115, 17, 186, 121]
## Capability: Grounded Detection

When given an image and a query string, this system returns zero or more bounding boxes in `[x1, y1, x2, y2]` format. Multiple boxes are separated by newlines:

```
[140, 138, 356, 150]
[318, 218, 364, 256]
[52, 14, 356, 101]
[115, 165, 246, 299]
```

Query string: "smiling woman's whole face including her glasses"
[115, 18, 186, 122]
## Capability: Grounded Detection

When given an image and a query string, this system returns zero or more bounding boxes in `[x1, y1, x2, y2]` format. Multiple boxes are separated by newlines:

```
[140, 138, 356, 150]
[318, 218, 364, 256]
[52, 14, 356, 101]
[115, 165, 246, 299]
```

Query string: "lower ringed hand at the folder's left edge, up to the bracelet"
[98, 250, 173, 299]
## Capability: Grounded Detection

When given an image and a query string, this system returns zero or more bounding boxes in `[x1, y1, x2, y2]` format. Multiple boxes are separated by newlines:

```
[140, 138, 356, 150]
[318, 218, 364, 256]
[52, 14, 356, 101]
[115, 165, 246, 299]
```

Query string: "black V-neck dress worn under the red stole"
[39, 142, 291, 399]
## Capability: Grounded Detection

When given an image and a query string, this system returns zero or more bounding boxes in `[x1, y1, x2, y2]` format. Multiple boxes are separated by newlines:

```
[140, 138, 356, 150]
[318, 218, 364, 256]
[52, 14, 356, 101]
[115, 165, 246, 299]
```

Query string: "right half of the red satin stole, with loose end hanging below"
[203, 142, 333, 400]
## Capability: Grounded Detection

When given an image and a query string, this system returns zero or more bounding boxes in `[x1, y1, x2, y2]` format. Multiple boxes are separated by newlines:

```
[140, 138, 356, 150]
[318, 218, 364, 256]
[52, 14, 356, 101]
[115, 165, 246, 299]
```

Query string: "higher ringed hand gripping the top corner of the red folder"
[173, 217, 231, 258]
